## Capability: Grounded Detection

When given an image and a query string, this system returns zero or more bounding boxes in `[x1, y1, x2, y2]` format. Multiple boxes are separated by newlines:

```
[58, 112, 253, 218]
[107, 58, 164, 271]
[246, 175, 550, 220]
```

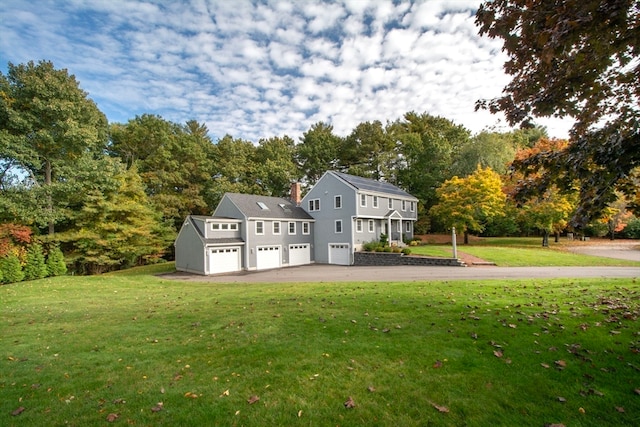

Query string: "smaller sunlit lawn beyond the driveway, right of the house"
[411, 237, 640, 267]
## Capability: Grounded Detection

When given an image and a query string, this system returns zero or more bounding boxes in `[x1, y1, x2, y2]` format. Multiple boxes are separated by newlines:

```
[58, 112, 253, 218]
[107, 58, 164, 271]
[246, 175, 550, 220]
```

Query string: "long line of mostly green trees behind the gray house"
[0, 61, 636, 280]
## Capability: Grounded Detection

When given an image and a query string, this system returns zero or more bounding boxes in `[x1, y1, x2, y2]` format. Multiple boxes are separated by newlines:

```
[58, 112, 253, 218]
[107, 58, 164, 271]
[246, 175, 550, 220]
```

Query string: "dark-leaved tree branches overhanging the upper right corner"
[476, 0, 640, 226]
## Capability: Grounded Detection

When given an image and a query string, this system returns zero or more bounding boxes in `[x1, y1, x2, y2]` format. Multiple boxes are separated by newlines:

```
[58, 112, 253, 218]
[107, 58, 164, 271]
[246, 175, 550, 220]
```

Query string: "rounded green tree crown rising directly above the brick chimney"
[296, 122, 341, 185]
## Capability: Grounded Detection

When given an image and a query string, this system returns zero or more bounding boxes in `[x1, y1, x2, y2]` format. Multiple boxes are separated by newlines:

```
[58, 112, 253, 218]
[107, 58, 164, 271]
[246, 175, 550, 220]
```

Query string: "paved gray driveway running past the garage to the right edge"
[160, 264, 640, 283]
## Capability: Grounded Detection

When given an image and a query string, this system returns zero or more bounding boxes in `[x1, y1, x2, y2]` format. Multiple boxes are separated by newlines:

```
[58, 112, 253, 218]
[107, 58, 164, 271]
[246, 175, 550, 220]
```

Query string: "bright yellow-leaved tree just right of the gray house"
[429, 167, 506, 244]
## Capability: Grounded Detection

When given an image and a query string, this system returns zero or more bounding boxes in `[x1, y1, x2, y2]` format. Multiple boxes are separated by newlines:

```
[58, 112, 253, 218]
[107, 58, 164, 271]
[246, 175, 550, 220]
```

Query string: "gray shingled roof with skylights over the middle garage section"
[225, 193, 313, 220]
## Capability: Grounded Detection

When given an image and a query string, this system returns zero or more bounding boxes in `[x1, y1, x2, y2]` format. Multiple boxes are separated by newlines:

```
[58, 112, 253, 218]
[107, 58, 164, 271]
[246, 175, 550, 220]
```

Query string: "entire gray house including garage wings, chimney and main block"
[175, 171, 418, 275]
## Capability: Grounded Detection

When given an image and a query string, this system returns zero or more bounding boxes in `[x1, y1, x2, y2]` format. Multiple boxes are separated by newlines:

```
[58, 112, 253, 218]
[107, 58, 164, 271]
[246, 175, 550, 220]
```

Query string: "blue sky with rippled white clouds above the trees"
[0, 0, 571, 143]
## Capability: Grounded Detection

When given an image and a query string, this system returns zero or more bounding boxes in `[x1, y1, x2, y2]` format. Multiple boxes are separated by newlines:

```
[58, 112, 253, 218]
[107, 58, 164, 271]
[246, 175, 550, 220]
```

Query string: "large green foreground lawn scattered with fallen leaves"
[0, 264, 640, 426]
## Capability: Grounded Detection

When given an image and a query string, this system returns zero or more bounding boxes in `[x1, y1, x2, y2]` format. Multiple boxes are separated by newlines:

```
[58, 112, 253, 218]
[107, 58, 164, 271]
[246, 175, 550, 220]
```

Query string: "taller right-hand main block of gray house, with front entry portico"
[302, 171, 418, 265]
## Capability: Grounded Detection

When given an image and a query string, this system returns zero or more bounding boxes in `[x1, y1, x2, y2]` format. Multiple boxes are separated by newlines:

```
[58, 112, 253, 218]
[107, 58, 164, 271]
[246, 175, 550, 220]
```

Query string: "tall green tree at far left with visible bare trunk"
[0, 61, 107, 234]
